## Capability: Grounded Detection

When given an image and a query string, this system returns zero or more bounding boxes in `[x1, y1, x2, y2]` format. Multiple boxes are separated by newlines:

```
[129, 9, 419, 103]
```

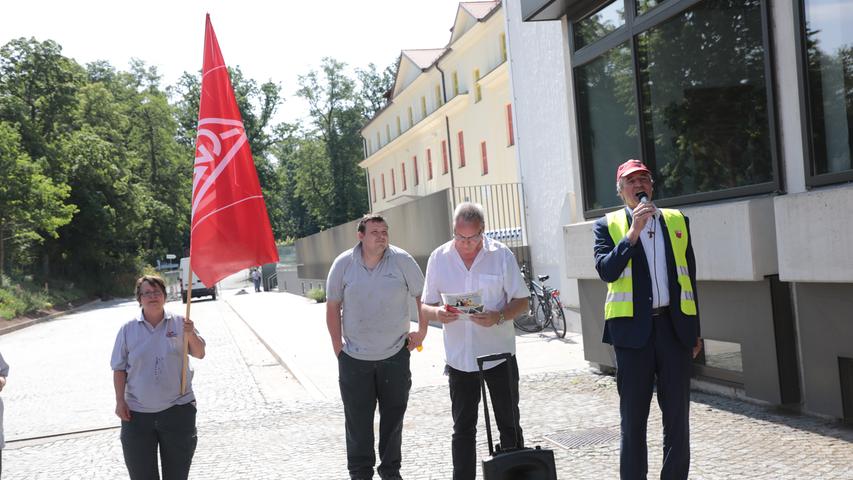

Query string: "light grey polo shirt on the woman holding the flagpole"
[110, 309, 204, 413]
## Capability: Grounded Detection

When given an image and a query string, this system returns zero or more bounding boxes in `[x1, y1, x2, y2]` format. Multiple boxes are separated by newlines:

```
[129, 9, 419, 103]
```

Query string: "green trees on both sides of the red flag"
[0, 34, 393, 294]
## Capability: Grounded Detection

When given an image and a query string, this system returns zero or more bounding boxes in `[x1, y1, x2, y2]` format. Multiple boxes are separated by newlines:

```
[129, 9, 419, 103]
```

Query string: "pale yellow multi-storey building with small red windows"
[360, 2, 519, 212]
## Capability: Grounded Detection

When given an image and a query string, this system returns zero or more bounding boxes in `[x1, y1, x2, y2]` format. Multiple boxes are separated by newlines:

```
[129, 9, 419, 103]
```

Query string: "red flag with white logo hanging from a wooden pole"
[190, 15, 278, 287]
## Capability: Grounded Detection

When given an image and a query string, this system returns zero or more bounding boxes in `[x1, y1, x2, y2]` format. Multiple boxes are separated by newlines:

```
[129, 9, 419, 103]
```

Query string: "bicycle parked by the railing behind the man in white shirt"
[513, 263, 566, 338]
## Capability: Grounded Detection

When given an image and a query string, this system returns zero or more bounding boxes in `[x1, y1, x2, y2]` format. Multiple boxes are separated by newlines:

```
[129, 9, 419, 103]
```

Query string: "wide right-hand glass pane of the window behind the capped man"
[637, 0, 773, 198]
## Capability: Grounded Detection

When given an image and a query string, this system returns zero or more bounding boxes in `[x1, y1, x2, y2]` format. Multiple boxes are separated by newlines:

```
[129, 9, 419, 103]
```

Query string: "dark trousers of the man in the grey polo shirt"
[338, 347, 412, 479]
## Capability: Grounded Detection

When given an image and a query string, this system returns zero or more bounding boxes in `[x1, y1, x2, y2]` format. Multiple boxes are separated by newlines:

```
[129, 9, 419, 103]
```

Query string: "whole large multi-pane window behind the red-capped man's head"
[572, 0, 778, 217]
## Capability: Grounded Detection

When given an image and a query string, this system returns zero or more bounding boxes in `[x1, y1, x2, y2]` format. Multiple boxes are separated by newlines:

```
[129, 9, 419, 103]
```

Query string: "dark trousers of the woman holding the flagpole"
[121, 403, 198, 480]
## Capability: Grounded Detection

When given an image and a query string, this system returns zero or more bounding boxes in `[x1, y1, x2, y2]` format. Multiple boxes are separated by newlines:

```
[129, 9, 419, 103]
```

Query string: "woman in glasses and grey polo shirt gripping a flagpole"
[110, 275, 205, 480]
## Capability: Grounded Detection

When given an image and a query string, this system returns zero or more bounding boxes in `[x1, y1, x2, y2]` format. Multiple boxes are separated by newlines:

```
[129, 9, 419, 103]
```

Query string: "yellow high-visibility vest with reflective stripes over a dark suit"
[604, 208, 696, 320]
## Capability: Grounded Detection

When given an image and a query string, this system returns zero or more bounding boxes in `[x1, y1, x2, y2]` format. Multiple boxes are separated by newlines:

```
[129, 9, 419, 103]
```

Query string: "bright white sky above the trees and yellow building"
[0, 0, 466, 121]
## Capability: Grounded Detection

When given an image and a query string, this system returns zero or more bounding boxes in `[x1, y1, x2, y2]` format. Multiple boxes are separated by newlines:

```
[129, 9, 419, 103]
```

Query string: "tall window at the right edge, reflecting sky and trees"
[801, 0, 853, 185]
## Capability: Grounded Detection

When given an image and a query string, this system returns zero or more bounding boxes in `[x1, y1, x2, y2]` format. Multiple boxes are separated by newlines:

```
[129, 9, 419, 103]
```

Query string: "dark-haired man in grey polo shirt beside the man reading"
[326, 214, 429, 480]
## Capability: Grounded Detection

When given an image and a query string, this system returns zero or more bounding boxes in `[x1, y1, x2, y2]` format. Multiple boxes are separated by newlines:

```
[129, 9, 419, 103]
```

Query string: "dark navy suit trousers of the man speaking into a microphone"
[616, 314, 692, 480]
